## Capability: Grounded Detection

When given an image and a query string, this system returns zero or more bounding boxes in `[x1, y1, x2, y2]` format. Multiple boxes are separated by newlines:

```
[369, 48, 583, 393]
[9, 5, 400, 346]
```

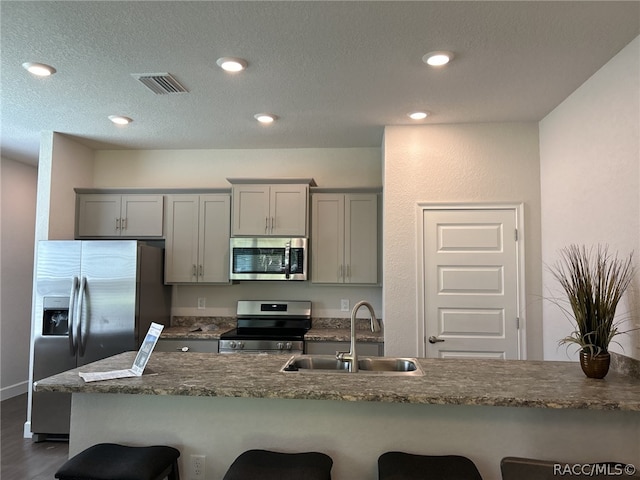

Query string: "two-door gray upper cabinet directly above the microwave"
[231, 183, 309, 237]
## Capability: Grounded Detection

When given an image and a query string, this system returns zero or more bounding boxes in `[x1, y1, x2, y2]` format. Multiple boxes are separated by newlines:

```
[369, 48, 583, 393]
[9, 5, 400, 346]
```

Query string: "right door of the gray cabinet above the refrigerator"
[120, 195, 163, 238]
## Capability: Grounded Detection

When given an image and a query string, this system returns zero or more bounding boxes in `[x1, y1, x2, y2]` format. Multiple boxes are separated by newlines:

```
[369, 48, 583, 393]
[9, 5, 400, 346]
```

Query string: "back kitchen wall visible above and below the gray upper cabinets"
[90, 148, 382, 317]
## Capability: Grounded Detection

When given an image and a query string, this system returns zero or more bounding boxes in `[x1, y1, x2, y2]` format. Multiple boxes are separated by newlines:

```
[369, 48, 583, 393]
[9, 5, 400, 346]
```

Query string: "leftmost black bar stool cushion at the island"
[55, 443, 180, 480]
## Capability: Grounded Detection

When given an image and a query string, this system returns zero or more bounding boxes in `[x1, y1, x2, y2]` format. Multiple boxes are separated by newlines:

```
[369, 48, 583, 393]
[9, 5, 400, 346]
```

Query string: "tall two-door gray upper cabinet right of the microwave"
[311, 193, 378, 284]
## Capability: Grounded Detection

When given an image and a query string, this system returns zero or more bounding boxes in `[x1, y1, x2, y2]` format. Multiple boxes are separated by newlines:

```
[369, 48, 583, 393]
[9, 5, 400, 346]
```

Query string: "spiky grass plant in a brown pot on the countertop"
[550, 245, 634, 378]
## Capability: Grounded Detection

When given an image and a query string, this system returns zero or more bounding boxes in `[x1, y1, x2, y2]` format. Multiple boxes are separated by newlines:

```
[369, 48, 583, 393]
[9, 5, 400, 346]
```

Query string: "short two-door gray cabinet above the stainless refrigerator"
[76, 193, 163, 239]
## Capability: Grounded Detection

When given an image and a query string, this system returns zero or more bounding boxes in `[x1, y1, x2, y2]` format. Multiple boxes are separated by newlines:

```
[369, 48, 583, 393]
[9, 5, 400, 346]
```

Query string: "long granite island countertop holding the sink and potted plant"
[34, 352, 640, 411]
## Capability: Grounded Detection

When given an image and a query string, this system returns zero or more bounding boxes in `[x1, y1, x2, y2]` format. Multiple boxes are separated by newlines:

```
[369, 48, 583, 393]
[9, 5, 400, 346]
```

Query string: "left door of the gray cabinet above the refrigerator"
[77, 194, 121, 238]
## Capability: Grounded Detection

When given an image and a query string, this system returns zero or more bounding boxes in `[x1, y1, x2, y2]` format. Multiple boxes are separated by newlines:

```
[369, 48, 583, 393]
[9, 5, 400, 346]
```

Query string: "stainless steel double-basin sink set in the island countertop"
[280, 355, 424, 377]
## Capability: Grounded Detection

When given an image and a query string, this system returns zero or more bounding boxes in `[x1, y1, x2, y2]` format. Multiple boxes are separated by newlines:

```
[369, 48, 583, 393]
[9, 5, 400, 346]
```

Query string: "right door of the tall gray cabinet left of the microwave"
[198, 194, 231, 283]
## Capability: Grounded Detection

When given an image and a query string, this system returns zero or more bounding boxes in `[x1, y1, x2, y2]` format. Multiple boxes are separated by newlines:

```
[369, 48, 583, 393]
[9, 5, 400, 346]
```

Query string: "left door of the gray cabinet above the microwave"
[232, 185, 271, 235]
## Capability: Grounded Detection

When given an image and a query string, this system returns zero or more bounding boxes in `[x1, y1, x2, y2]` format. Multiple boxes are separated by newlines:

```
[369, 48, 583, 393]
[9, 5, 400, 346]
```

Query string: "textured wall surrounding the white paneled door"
[383, 123, 542, 359]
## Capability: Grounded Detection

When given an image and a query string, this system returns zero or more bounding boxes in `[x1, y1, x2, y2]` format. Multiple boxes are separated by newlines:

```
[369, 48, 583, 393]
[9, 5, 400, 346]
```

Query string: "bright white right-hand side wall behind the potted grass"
[540, 37, 640, 360]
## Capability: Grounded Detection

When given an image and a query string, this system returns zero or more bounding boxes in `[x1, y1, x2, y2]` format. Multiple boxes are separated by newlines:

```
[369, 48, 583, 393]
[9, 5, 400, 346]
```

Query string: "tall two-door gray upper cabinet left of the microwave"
[165, 193, 231, 283]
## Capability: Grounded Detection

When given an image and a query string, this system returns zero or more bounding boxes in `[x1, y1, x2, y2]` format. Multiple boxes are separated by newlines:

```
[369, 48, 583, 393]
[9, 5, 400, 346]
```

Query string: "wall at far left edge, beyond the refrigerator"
[0, 158, 38, 400]
